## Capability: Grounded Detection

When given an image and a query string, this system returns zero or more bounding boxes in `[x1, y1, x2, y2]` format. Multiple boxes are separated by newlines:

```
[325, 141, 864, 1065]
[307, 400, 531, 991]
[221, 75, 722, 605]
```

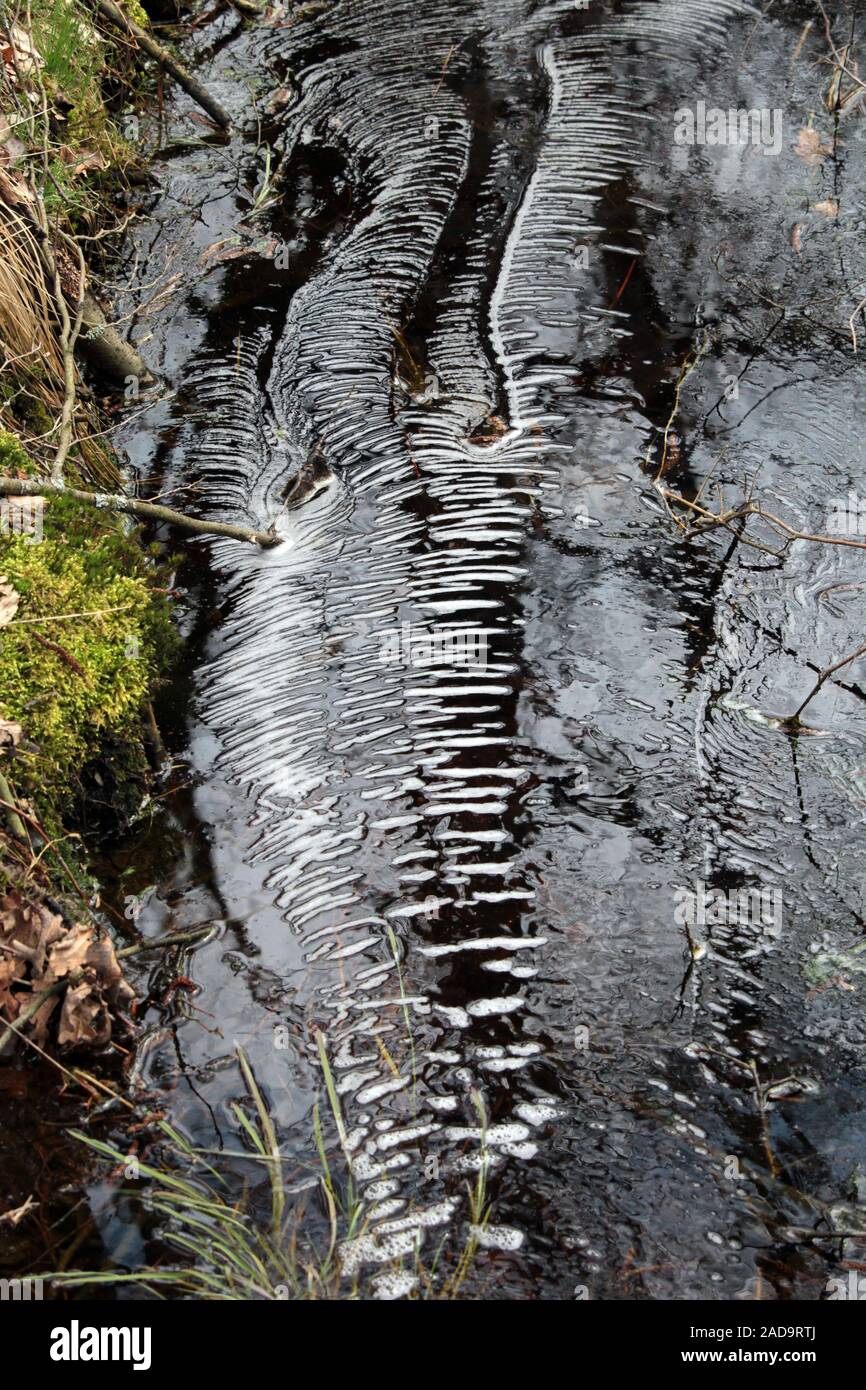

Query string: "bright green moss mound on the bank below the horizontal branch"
[0, 498, 177, 813]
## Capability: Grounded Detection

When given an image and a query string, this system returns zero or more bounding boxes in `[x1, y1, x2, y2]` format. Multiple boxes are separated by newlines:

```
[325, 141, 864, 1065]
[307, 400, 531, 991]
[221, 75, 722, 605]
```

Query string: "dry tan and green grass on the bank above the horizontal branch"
[0, 0, 139, 485]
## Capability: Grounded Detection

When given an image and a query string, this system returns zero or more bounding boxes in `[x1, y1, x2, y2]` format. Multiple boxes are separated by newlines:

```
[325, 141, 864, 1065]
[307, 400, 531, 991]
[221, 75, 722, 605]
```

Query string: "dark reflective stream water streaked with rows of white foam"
[91, 0, 866, 1300]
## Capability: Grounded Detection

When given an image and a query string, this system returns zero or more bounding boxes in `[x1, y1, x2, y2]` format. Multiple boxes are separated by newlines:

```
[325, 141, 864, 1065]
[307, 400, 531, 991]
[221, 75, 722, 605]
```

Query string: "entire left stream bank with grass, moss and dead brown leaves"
[0, 3, 189, 1278]
